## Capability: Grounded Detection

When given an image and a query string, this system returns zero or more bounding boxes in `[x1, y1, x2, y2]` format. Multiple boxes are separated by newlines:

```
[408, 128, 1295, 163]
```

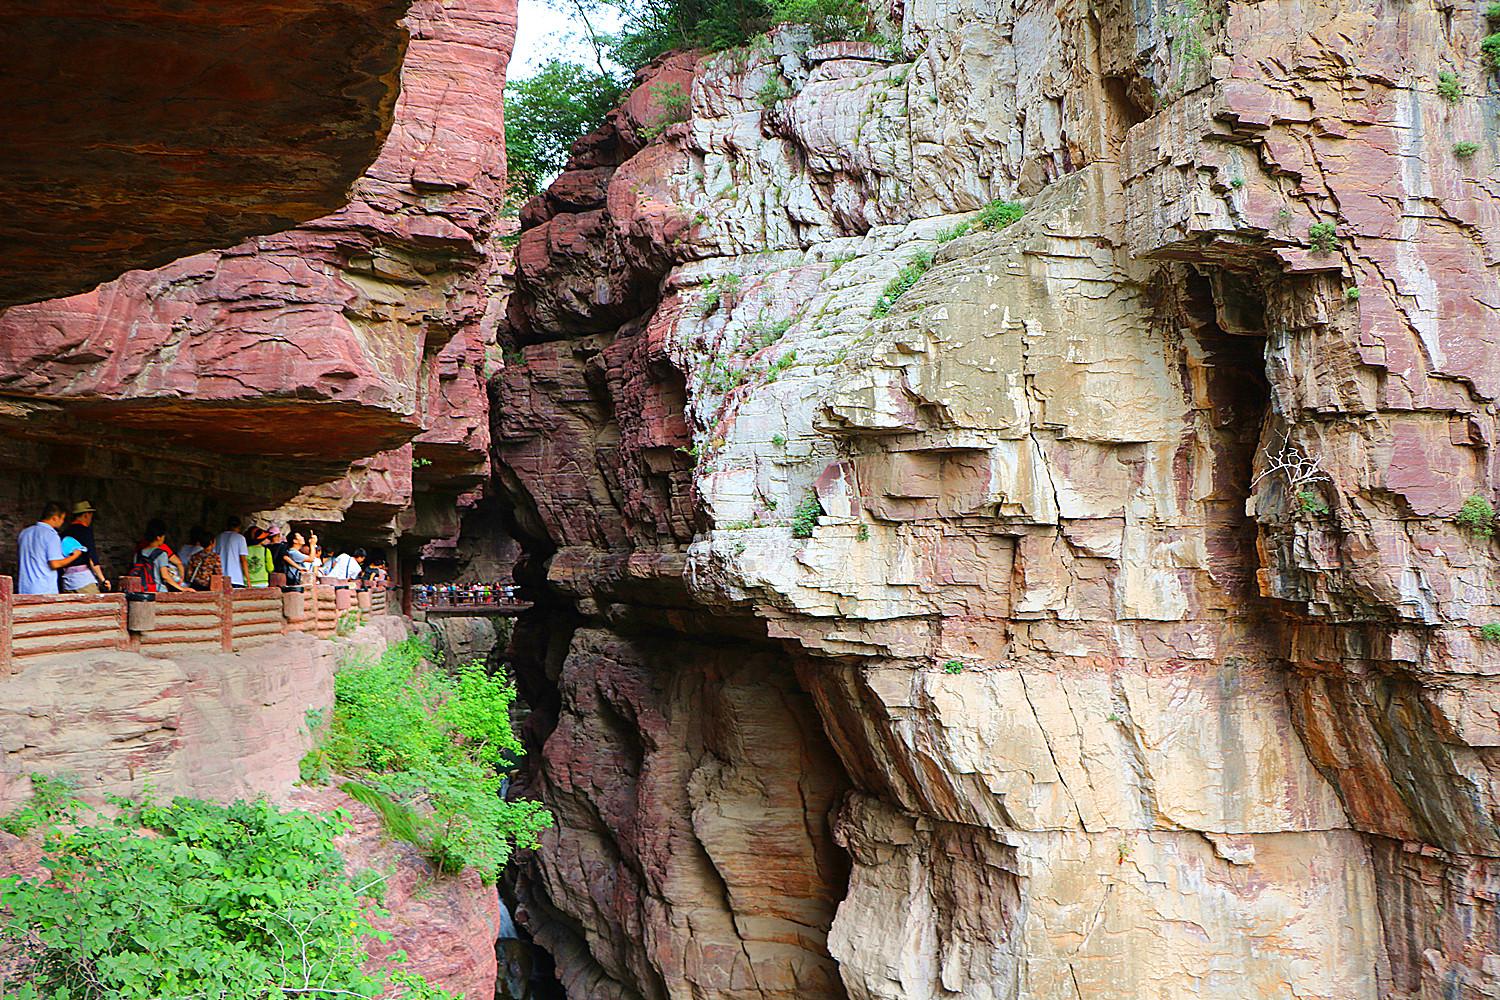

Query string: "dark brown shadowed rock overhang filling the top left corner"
[0, 0, 410, 307]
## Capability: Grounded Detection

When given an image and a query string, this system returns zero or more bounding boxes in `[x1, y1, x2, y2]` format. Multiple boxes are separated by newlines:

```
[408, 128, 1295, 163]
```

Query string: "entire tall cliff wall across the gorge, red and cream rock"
[494, 0, 1500, 1000]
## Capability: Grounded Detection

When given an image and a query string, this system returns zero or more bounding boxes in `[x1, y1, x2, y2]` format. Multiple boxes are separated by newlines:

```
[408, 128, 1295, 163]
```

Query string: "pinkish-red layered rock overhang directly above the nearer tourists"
[0, 0, 515, 563]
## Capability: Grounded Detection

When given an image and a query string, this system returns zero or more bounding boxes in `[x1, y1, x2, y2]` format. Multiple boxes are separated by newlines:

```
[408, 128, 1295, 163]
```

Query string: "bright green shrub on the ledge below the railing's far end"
[303, 639, 551, 882]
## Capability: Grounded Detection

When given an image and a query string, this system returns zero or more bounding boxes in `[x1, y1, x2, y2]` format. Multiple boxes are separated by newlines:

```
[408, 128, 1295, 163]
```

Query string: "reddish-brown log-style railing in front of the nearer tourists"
[0, 574, 389, 675]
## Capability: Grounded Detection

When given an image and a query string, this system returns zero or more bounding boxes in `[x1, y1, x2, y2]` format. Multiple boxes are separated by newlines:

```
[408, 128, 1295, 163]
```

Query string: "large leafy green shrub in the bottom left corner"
[0, 799, 449, 1000]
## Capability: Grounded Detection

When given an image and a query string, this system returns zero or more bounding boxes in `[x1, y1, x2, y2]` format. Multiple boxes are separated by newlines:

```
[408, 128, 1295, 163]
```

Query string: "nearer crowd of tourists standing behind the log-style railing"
[15, 501, 389, 594]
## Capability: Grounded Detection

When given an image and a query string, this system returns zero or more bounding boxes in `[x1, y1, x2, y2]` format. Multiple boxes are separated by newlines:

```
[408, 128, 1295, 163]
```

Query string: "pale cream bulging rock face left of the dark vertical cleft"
[651, 168, 1382, 1000]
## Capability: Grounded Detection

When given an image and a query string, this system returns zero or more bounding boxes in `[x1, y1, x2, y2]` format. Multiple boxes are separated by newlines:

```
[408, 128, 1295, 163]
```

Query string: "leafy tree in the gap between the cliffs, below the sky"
[506, 58, 624, 198]
